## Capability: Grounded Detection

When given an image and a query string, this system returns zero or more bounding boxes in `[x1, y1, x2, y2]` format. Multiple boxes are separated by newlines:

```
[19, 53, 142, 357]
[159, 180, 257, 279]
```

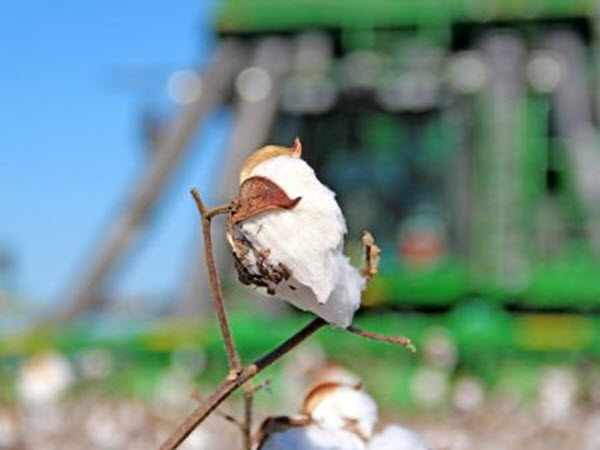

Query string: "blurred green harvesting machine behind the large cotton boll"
[43, 0, 600, 376]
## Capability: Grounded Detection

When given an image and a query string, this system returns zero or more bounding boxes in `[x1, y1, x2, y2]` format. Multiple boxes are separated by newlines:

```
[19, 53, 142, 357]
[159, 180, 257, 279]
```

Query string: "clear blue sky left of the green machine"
[0, 0, 229, 304]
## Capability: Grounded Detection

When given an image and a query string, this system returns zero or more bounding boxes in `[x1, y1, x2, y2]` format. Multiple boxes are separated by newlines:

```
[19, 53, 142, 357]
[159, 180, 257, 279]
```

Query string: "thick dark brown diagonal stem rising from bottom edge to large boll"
[160, 317, 326, 450]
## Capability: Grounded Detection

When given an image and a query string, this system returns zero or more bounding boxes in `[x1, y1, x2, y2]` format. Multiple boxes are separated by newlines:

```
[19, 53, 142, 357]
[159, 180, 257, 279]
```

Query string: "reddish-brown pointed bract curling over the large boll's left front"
[229, 176, 302, 224]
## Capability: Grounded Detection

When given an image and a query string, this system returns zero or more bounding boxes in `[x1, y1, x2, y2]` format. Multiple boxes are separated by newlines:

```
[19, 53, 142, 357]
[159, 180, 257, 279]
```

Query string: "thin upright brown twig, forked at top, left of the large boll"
[191, 188, 242, 379]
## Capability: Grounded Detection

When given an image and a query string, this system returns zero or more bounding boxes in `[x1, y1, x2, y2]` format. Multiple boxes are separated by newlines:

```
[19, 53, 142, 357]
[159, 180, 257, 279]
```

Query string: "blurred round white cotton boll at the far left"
[17, 353, 74, 406]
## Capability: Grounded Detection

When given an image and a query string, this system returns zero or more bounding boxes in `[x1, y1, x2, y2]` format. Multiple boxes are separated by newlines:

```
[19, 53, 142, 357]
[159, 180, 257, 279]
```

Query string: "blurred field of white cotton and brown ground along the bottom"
[0, 344, 600, 450]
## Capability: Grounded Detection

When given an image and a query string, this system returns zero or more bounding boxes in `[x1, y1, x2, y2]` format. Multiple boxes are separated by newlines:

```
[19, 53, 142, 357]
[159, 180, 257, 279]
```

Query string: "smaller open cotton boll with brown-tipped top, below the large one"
[302, 383, 377, 440]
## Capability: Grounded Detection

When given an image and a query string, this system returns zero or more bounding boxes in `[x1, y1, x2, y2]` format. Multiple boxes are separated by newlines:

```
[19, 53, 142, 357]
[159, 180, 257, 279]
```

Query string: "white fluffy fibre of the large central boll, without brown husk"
[237, 155, 365, 328]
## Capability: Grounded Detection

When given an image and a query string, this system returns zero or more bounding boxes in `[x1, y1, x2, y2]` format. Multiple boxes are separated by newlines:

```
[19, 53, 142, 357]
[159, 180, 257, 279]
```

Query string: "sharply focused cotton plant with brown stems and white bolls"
[161, 139, 415, 450]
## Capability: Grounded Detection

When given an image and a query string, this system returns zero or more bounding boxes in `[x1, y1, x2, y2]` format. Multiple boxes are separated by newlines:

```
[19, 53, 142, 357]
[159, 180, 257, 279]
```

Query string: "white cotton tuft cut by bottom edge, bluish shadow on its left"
[259, 425, 365, 450]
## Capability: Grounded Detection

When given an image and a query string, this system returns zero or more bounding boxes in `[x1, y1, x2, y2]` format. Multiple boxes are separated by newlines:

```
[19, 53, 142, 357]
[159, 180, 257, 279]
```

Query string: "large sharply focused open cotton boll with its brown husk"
[228, 141, 365, 328]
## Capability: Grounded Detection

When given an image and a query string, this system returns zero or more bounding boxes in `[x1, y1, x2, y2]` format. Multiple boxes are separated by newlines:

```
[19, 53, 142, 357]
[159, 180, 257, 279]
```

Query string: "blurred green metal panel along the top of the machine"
[216, 0, 596, 33]
